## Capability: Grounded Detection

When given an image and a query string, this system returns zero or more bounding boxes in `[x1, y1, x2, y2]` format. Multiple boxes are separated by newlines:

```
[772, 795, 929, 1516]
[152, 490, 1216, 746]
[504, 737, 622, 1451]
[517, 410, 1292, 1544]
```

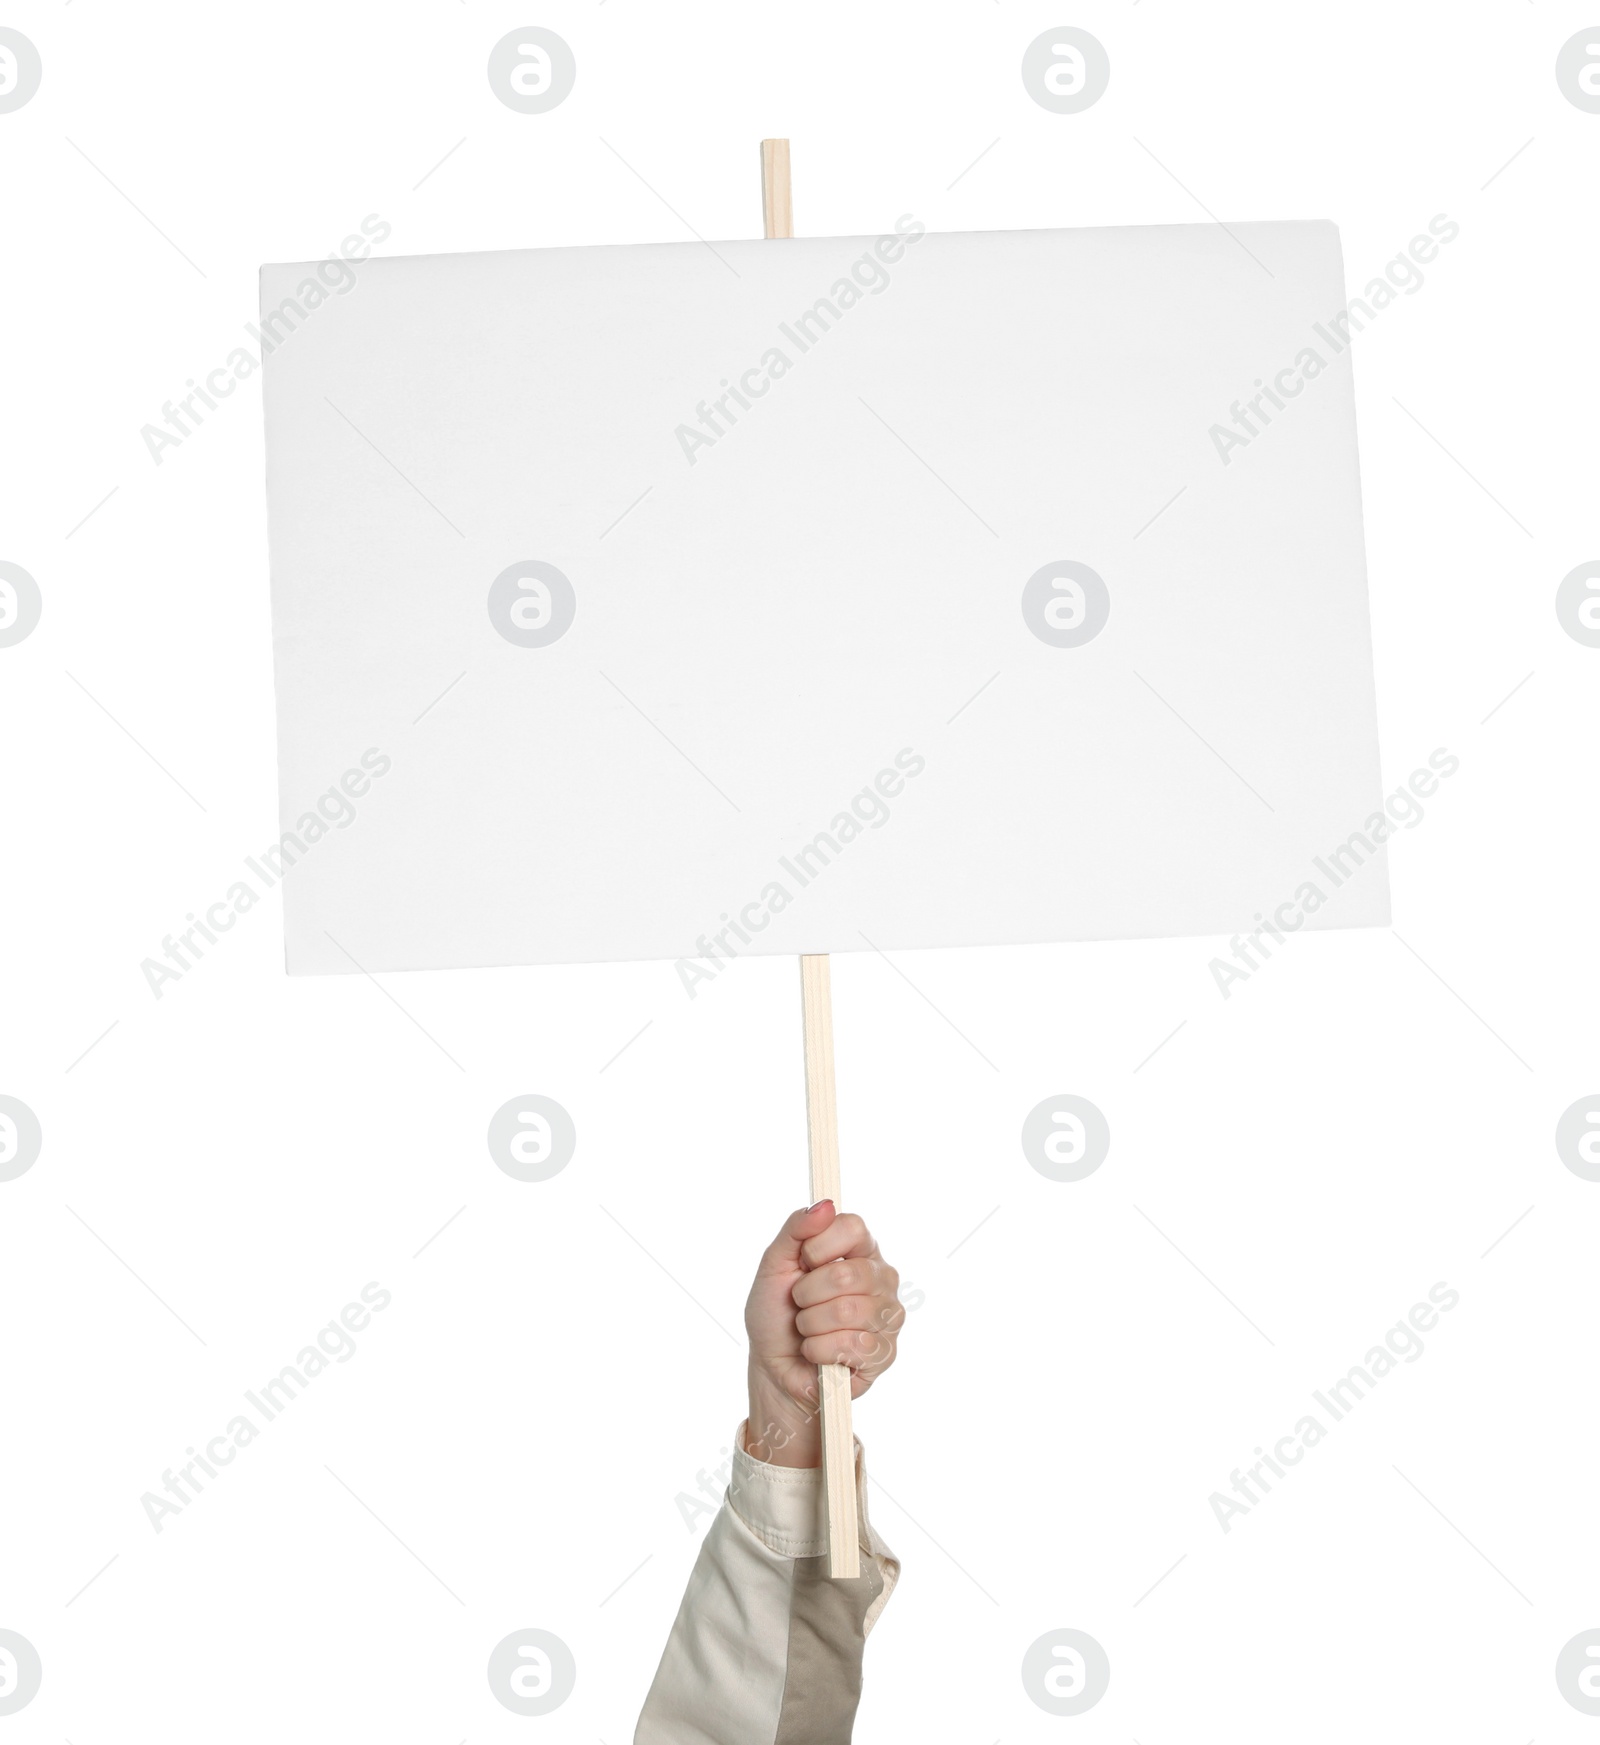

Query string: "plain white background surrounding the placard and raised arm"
[0, 0, 1600, 1745]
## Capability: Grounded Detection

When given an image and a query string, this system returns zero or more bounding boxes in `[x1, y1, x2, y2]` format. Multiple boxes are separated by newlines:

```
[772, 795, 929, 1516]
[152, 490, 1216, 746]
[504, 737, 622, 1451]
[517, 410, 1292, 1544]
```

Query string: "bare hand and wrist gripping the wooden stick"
[745, 1201, 906, 1466]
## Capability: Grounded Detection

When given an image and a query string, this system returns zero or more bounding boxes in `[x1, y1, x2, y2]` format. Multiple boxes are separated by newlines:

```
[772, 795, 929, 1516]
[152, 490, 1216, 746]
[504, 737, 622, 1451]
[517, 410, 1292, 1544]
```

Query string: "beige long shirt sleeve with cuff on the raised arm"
[633, 1424, 900, 1745]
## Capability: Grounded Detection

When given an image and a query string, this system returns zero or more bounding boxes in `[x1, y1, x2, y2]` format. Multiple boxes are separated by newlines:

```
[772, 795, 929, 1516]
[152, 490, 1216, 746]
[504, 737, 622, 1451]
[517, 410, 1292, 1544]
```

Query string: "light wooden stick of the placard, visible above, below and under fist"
[761, 140, 862, 1581]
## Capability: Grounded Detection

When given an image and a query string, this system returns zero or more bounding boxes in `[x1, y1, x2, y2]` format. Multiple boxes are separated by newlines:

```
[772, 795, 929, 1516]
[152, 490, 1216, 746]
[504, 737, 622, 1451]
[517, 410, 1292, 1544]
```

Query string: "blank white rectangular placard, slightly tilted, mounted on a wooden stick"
[262, 222, 1387, 972]
